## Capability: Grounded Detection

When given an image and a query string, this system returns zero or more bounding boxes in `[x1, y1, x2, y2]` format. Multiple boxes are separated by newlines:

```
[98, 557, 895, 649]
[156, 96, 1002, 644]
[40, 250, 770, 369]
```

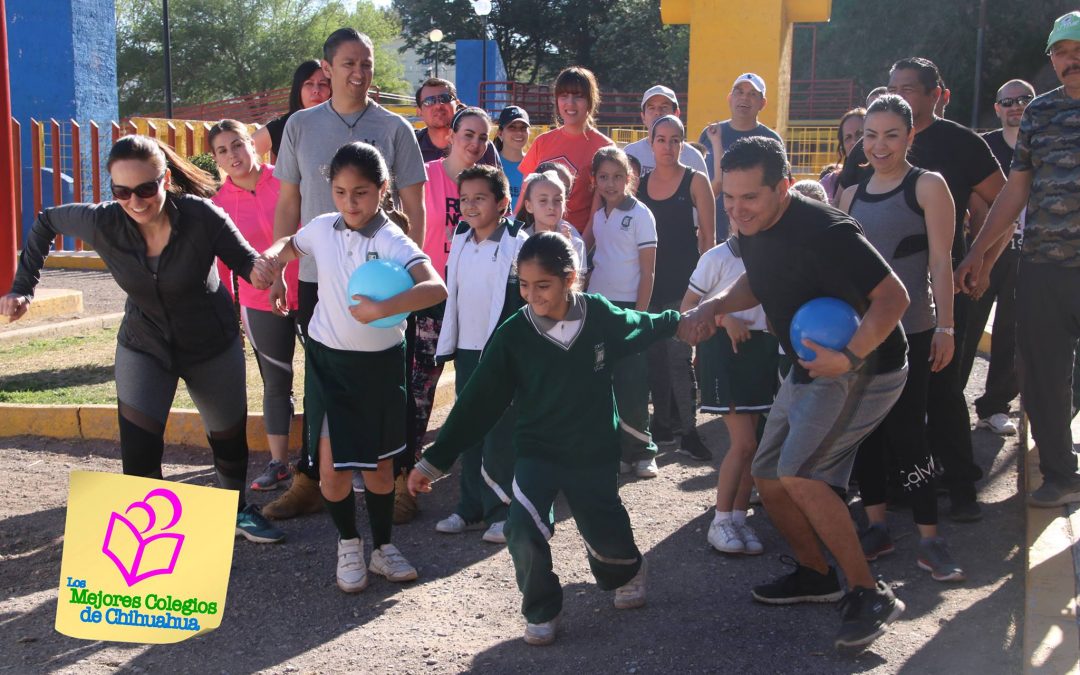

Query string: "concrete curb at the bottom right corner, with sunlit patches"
[1022, 431, 1080, 675]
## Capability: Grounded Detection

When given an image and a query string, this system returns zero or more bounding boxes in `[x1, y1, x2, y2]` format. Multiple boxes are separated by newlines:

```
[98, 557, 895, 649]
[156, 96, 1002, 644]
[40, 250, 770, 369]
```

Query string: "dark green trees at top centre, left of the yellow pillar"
[393, 0, 689, 91]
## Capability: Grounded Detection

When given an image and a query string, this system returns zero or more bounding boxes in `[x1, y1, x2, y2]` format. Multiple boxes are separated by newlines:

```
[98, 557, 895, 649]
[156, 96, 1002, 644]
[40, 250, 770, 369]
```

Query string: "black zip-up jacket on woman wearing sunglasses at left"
[12, 194, 258, 372]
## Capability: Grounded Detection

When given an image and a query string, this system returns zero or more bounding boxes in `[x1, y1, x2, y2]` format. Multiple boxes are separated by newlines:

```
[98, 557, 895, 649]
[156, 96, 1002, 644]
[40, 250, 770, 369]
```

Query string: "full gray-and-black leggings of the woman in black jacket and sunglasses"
[116, 337, 247, 509]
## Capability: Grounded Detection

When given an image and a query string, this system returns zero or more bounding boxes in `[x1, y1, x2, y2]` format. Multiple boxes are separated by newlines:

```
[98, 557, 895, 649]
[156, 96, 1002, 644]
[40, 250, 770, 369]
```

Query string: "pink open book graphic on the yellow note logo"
[102, 488, 184, 586]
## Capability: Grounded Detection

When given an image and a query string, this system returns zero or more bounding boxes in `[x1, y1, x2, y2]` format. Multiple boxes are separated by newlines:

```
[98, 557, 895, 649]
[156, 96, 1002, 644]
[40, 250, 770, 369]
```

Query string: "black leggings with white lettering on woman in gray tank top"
[855, 329, 933, 525]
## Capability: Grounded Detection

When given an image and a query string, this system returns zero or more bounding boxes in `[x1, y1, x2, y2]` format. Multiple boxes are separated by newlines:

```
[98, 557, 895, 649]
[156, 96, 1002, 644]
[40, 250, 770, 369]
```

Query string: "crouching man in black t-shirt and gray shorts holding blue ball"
[679, 137, 908, 647]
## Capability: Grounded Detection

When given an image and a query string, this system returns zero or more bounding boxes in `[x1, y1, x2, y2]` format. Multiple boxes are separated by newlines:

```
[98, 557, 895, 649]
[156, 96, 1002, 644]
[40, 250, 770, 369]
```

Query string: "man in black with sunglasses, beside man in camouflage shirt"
[960, 80, 1035, 435]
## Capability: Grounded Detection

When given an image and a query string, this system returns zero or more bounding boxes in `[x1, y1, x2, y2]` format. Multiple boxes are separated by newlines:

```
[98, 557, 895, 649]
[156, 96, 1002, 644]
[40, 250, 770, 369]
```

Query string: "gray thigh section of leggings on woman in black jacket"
[116, 338, 247, 434]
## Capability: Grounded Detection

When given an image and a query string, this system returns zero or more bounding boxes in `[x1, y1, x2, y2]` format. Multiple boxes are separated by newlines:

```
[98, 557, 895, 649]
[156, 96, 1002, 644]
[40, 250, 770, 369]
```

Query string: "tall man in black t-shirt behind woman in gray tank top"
[839, 57, 1005, 522]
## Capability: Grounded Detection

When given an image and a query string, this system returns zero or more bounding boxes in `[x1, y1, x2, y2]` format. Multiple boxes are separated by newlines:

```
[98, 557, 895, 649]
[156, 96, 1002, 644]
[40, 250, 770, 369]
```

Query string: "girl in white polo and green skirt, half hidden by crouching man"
[679, 237, 779, 555]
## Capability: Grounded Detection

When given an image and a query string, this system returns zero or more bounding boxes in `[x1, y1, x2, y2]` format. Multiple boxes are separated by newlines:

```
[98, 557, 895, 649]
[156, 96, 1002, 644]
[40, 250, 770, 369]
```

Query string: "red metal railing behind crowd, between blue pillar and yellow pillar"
[480, 81, 687, 126]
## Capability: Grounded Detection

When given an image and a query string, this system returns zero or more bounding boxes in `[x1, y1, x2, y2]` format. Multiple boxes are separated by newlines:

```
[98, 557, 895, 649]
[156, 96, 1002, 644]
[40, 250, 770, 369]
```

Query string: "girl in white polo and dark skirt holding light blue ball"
[259, 143, 446, 593]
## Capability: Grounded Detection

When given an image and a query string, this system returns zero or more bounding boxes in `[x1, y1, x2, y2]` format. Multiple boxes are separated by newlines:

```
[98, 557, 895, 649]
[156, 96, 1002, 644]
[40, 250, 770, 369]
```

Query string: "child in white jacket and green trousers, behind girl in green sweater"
[435, 165, 526, 543]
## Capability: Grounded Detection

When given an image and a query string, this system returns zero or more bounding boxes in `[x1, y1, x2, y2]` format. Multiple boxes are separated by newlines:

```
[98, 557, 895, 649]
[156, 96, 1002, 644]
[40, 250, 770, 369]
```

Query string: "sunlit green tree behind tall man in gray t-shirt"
[117, 0, 408, 117]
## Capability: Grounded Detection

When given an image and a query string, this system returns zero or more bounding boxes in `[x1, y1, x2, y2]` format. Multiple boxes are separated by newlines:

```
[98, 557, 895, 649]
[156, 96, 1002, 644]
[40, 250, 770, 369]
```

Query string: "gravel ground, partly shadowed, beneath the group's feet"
[0, 360, 1025, 675]
